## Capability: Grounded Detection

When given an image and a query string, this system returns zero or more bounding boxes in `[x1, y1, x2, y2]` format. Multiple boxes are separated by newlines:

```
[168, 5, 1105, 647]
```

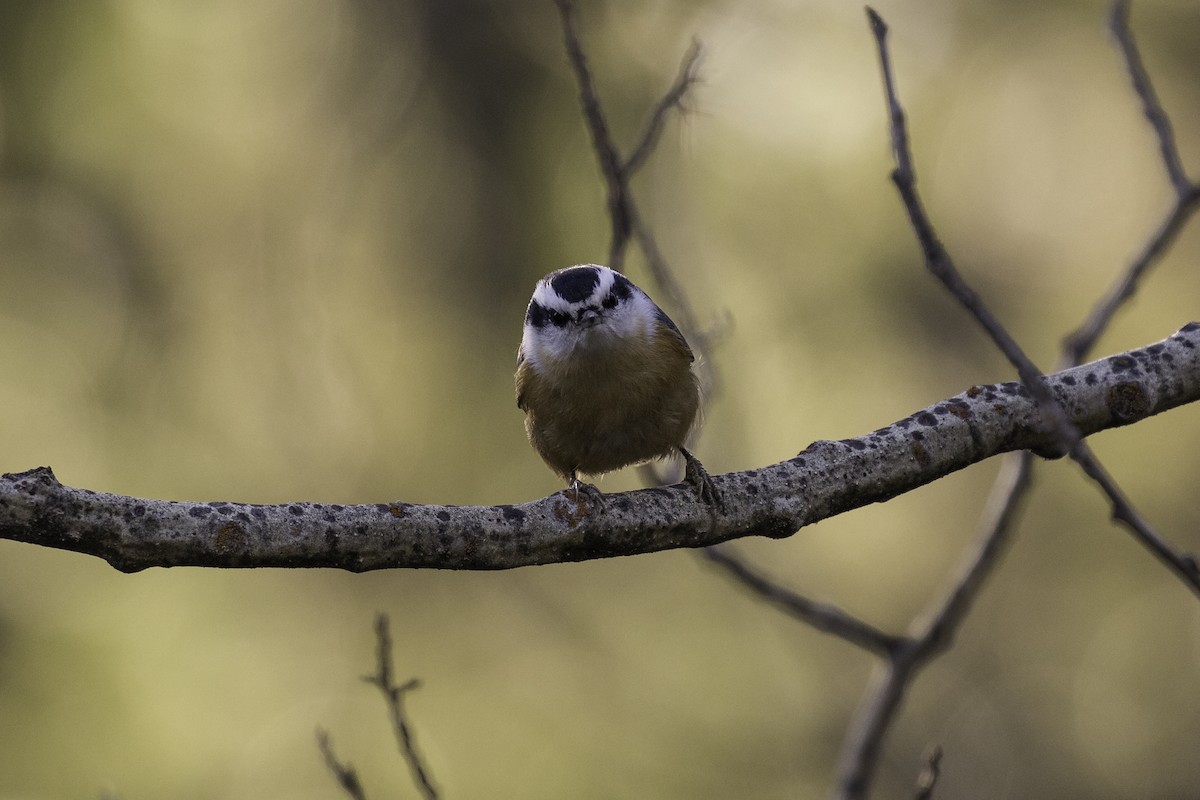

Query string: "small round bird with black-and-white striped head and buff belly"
[516, 264, 720, 505]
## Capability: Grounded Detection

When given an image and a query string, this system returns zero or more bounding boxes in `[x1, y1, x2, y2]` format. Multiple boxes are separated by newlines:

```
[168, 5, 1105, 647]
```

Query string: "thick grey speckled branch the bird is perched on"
[0, 323, 1200, 572]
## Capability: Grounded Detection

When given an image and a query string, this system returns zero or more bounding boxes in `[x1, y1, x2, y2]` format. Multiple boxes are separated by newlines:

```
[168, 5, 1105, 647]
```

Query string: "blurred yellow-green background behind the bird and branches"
[0, 0, 1200, 800]
